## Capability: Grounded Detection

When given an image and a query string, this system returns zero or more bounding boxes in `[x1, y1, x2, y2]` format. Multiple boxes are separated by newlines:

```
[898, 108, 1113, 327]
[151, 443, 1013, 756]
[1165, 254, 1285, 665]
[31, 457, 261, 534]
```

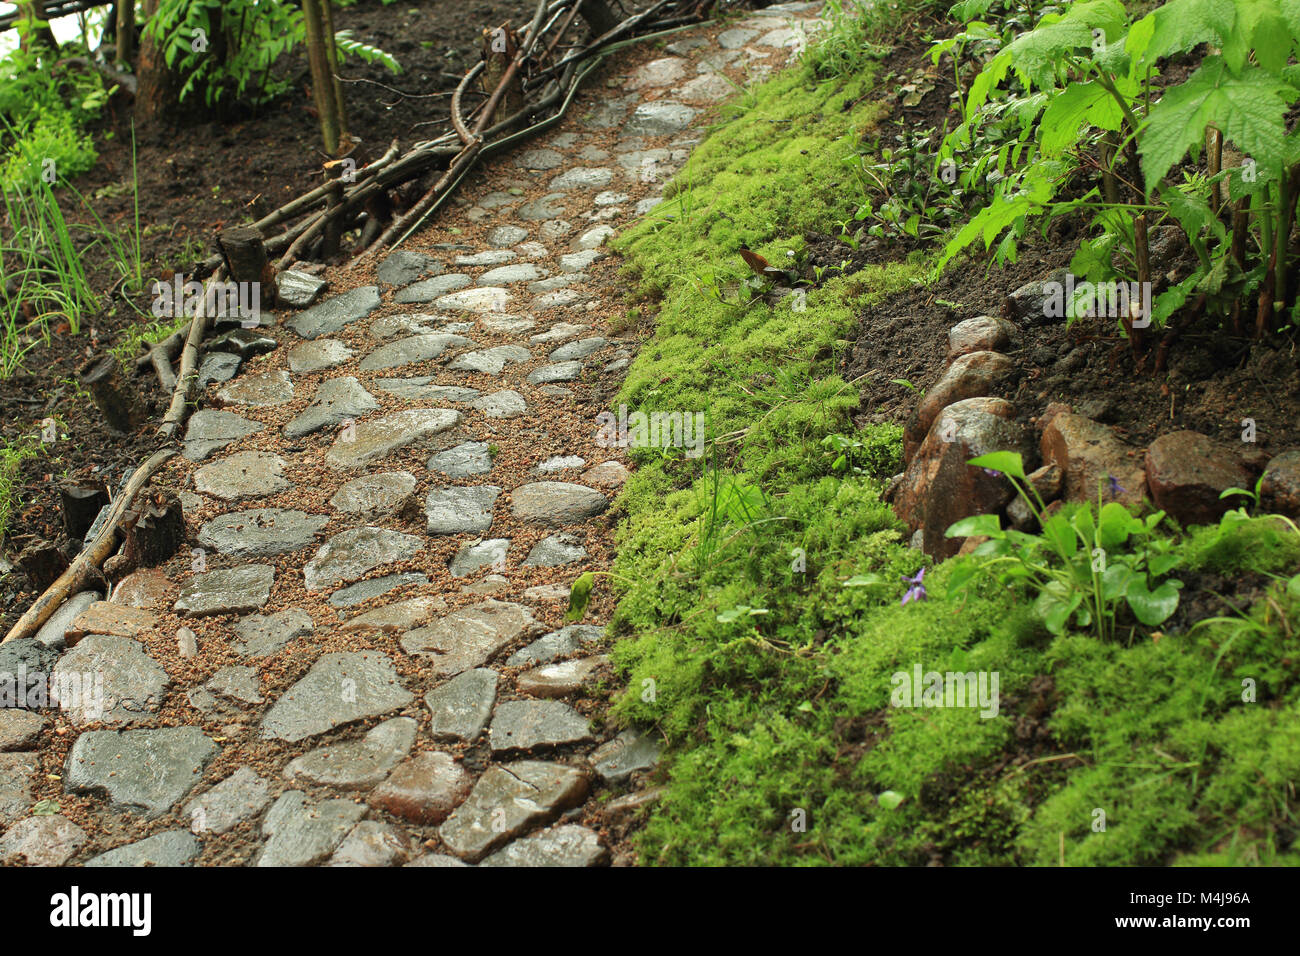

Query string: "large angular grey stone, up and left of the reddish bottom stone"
[261, 650, 415, 743]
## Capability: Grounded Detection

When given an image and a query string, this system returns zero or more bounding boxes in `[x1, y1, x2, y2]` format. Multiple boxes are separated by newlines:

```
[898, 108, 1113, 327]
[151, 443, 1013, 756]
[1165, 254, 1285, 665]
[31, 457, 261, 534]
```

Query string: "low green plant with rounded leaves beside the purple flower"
[945, 451, 1183, 640]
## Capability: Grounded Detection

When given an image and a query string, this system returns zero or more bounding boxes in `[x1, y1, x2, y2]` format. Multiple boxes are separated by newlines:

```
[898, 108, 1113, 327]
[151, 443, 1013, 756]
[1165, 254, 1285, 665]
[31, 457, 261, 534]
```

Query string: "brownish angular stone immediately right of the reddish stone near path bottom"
[438, 760, 589, 862]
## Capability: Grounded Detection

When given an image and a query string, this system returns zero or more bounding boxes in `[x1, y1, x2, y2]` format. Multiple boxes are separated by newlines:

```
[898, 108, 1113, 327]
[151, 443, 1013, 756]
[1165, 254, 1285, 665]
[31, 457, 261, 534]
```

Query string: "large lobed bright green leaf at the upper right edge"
[1140, 56, 1300, 193]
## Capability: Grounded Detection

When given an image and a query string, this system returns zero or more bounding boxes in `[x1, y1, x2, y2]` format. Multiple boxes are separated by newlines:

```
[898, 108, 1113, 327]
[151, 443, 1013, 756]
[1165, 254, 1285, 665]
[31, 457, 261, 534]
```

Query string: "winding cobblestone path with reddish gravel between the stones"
[0, 4, 814, 866]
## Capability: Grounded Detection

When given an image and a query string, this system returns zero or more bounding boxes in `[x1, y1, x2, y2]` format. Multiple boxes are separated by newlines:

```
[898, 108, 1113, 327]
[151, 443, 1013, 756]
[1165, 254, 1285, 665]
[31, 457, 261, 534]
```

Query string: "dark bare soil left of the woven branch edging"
[0, 0, 534, 632]
